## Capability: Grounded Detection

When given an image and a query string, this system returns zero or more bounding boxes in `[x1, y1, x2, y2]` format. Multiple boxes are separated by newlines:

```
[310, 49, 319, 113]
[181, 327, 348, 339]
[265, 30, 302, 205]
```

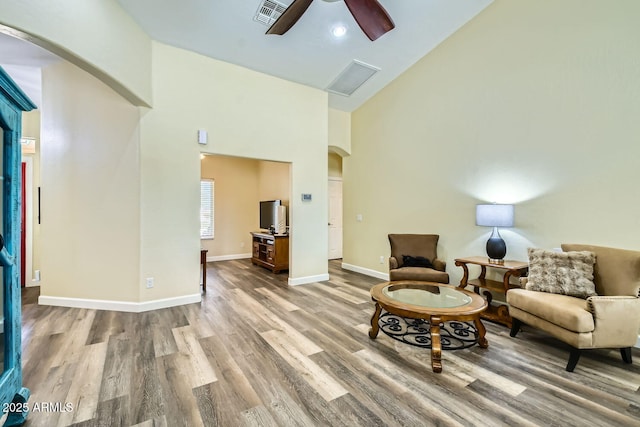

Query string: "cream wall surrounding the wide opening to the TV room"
[140, 42, 328, 300]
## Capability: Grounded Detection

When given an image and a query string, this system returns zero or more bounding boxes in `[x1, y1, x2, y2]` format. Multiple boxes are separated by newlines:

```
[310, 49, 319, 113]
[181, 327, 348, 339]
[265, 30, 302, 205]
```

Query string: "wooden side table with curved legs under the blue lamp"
[455, 256, 529, 327]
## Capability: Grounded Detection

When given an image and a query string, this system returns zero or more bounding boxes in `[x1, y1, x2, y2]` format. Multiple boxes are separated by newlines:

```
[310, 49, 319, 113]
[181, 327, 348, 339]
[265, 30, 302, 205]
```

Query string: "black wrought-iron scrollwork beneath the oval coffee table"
[378, 311, 478, 350]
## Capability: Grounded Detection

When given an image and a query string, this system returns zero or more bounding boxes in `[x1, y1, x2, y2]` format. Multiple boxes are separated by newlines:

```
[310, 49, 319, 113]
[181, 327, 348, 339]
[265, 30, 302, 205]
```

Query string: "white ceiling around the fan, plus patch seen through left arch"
[0, 0, 493, 111]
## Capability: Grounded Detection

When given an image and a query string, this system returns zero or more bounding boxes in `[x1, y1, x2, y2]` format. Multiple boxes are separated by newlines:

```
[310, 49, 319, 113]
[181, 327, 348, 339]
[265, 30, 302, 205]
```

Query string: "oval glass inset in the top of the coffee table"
[382, 284, 471, 308]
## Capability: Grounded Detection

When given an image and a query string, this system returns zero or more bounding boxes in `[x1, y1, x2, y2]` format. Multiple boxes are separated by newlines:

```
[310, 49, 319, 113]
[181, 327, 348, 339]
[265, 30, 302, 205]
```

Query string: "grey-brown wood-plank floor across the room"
[17, 260, 640, 427]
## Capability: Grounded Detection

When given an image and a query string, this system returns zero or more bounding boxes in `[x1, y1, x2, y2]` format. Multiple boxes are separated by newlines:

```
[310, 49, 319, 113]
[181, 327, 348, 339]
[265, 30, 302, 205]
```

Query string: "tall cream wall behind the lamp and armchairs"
[344, 0, 640, 282]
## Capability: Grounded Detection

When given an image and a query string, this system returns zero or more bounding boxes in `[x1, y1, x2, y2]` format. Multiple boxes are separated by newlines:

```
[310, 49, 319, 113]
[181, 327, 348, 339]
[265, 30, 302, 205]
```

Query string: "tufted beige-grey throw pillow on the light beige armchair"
[525, 248, 597, 298]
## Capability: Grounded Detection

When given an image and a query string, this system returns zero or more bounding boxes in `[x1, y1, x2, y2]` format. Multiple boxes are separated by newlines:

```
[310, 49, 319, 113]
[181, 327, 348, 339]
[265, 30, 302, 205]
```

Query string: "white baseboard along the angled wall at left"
[38, 294, 202, 313]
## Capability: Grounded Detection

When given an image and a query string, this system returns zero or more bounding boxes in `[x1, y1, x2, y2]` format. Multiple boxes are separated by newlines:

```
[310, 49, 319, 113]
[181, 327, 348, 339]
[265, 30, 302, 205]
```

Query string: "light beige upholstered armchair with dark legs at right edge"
[507, 244, 640, 372]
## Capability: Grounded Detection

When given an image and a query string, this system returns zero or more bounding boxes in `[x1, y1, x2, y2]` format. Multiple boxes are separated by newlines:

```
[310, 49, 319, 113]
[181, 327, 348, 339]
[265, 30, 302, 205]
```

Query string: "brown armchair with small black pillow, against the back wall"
[389, 234, 449, 283]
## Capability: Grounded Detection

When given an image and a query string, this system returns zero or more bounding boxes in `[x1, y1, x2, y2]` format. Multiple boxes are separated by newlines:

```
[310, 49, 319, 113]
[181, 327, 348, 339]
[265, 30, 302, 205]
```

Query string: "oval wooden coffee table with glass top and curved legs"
[369, 280, 489, 372]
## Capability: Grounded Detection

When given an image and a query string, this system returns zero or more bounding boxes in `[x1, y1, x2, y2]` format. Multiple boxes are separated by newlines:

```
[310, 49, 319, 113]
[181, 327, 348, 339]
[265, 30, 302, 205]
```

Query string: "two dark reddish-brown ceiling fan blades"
[267, 0, 395, 41]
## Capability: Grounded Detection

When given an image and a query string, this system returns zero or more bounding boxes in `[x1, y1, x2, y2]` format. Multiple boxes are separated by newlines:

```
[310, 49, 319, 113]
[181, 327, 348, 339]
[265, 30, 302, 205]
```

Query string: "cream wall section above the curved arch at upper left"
[0, 0, 151, 105]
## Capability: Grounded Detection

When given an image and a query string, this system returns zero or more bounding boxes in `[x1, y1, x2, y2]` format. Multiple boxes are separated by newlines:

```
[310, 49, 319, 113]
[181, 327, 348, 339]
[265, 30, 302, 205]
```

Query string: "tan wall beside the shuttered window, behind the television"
[201, 156, 260, 259]
